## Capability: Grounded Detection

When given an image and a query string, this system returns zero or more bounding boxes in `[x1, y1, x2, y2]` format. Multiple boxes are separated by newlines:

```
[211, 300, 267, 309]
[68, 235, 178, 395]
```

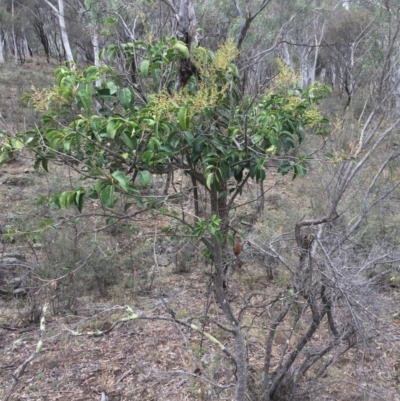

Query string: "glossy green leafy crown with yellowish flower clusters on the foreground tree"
[1, 38, 328, 244]
